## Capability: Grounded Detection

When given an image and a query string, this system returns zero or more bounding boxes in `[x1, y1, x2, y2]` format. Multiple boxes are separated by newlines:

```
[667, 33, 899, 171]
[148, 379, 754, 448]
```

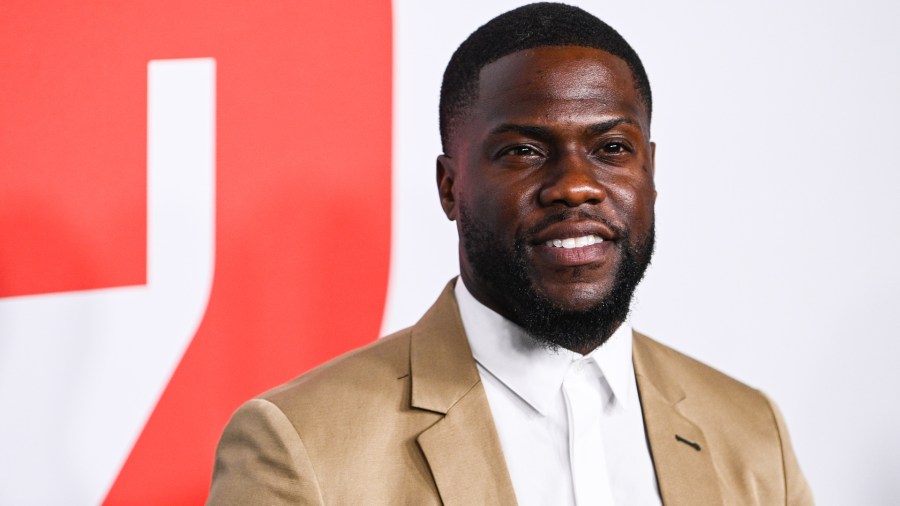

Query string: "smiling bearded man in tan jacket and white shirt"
[210, 4, 812, 505]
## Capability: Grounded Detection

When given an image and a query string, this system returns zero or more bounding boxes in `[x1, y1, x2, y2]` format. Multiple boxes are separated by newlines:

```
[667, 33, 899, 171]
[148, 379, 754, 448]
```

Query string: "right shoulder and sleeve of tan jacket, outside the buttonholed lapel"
[633, 332, 813, 505]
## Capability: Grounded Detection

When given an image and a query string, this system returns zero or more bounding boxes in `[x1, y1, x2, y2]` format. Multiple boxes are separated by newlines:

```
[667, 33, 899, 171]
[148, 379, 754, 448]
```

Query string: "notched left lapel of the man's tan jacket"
[410, 282, 516, 506]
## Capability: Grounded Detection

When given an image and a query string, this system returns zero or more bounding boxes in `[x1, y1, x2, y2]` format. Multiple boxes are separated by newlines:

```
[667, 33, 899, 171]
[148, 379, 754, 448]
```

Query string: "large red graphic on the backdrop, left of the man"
[0, 0, 392, 504]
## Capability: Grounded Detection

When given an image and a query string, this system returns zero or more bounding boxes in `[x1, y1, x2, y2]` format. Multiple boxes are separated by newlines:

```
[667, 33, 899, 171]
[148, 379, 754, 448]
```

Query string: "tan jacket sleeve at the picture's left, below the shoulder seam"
[206, 399, 324, 505]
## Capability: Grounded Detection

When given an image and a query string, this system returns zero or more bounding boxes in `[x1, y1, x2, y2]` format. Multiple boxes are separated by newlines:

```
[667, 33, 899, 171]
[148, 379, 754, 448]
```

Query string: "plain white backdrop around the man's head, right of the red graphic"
[384, 0, 900, 505]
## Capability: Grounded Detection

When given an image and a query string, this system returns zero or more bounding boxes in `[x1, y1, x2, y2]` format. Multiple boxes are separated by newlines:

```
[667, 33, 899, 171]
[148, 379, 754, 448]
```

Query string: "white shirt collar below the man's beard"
[455, 278, 637, 415]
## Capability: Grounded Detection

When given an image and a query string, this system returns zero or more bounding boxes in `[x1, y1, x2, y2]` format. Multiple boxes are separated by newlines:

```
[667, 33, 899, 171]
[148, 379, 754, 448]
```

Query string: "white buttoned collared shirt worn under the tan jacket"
[456, 279, 662, 506]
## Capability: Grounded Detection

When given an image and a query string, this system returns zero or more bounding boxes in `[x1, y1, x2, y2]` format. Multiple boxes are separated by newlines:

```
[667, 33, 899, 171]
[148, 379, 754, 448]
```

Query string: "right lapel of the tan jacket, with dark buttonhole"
[634, 333, 722, 505]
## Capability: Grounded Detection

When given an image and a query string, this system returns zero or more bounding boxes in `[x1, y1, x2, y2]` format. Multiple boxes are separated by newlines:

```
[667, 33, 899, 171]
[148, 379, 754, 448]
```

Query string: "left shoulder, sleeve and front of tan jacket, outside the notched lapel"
[210, 329, 450, 504]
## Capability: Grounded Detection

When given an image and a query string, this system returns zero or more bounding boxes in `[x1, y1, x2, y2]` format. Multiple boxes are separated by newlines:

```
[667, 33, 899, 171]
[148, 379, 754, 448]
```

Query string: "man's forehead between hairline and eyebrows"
[470, 46, 649, 132]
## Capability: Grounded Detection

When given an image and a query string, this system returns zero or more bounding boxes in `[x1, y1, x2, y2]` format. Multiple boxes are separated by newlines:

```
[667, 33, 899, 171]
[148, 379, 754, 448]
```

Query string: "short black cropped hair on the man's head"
[439, 2, 653, 153]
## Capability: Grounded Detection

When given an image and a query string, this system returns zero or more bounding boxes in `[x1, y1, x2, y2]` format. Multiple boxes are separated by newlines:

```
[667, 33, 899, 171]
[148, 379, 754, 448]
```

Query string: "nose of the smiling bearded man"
[539, 153, 606, 207]
